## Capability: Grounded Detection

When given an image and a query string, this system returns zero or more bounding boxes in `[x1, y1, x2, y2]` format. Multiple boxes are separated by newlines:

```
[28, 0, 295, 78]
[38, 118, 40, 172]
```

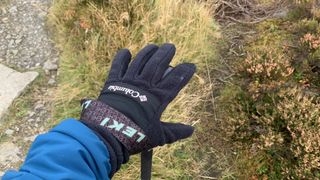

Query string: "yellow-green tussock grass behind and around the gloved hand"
[49, 0, 219, 179]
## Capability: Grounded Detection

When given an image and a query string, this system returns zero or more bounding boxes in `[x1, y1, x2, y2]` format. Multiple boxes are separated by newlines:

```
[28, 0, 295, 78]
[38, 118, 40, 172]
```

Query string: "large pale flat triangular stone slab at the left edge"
[0, 64, 39, 120]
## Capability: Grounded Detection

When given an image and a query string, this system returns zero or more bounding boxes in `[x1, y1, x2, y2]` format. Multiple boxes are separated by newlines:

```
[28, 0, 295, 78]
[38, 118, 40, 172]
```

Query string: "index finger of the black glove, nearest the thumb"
[158, 63, 196, 93]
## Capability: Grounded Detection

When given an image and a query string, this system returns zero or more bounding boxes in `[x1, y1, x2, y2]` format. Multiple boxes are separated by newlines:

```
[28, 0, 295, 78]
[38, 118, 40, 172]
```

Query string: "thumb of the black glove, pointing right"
[161, 122, 194, 144]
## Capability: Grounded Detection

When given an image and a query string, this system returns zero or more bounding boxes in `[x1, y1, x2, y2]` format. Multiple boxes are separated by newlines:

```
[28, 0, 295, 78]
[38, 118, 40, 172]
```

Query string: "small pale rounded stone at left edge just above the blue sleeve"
[0, 142, 20, 165]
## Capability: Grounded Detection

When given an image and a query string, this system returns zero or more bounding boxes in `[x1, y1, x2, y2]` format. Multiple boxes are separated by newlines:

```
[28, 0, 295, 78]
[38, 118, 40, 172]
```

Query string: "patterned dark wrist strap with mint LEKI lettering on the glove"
[80, 100, 152, 154]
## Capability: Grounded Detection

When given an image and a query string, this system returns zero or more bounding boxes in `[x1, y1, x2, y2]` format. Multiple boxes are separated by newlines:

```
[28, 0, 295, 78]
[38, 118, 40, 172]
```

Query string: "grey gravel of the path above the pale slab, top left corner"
[0, 0, 58, 69]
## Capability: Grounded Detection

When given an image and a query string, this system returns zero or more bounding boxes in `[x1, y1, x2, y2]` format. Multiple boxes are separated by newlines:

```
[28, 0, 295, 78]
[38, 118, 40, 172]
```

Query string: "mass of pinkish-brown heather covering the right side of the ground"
[219, 15, 320, 179]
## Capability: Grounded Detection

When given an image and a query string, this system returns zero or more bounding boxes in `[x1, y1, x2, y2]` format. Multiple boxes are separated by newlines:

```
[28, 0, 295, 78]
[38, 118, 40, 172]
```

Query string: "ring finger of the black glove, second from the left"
[124, 44, 159, 79]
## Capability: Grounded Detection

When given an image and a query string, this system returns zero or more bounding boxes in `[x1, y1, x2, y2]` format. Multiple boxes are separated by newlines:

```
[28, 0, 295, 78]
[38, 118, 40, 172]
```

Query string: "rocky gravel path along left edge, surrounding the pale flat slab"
[0, 0, 58, 176]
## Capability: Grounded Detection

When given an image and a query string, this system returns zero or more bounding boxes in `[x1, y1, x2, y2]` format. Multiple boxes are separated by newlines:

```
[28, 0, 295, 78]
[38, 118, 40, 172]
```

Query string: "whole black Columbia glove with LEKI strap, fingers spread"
[80, 44, 195, 176]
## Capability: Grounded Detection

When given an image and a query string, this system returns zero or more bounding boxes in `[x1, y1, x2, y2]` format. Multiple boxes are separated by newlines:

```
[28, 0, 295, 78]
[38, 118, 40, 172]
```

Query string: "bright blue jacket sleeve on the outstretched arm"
[3, 119, 111, 180]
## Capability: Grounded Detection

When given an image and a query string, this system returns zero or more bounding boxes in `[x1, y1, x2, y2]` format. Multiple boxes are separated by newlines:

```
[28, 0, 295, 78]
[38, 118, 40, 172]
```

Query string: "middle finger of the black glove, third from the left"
[139, 44, 176, 84]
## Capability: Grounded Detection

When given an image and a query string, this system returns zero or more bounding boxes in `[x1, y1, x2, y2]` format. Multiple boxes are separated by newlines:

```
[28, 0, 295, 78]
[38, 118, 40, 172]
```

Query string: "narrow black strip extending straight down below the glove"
[141, 149, 153, 180]
